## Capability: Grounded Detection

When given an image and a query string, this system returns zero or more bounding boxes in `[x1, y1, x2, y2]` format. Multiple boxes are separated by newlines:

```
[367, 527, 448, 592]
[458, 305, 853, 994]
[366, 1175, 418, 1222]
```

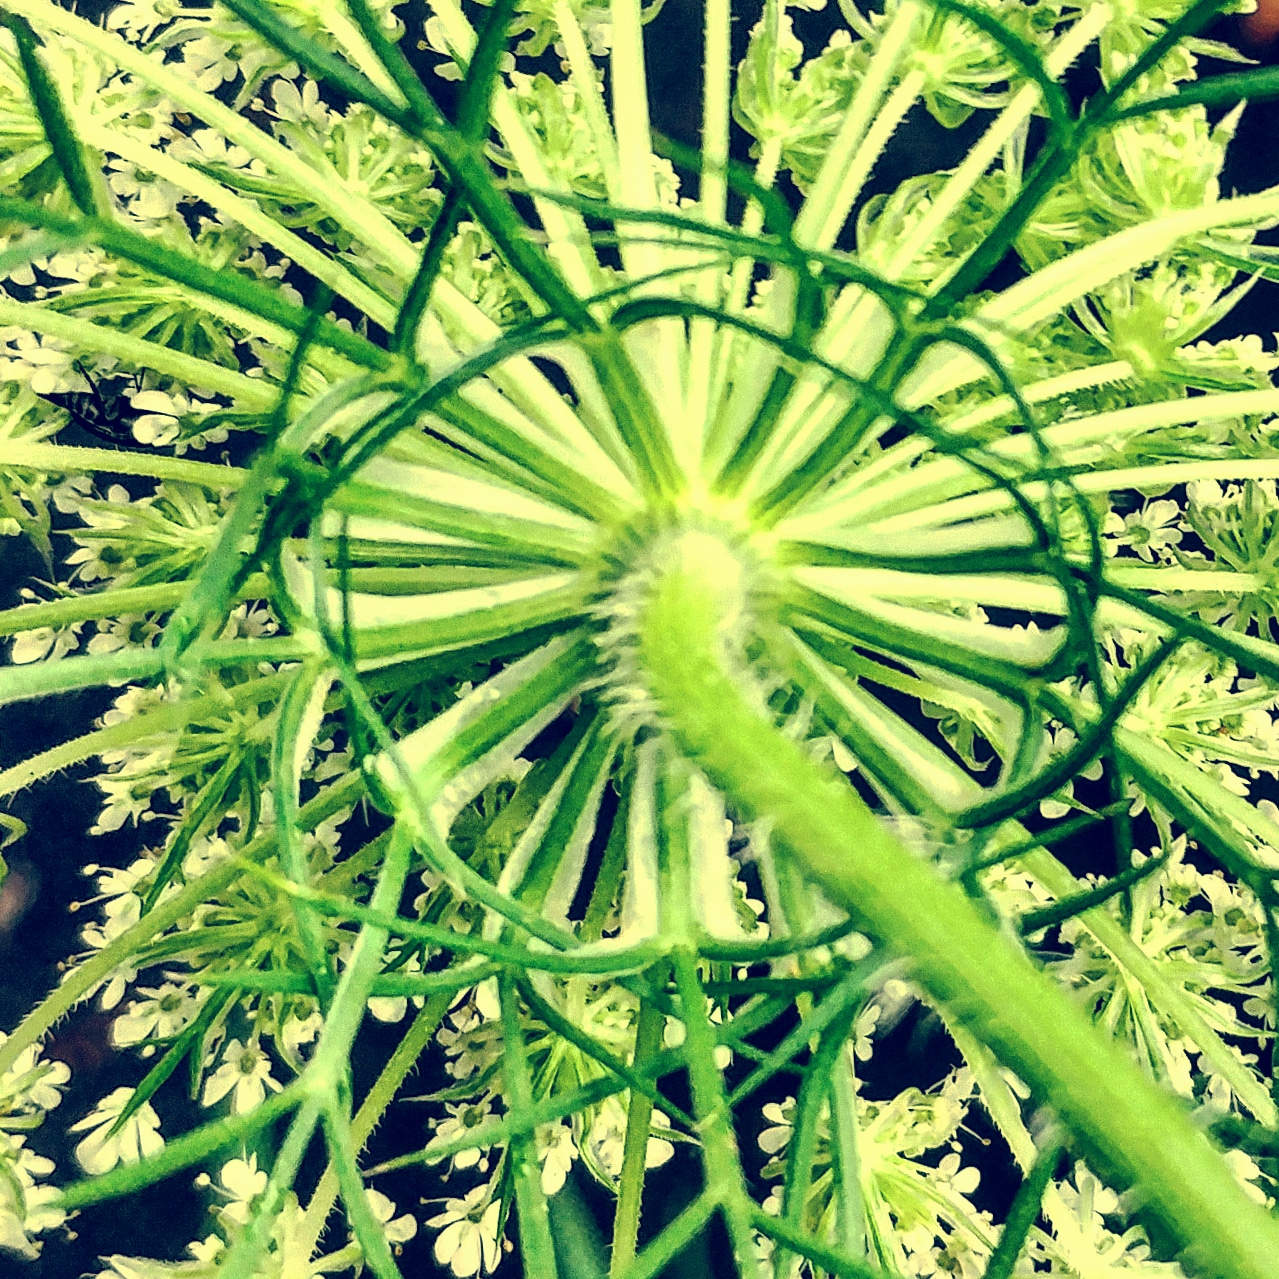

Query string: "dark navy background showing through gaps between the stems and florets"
[0, 0, 1279, 1279]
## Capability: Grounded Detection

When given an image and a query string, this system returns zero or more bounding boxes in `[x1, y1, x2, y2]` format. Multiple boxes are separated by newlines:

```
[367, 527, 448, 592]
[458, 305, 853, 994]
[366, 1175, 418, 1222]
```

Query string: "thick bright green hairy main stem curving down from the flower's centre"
[640, 533, 1279, 1279]
